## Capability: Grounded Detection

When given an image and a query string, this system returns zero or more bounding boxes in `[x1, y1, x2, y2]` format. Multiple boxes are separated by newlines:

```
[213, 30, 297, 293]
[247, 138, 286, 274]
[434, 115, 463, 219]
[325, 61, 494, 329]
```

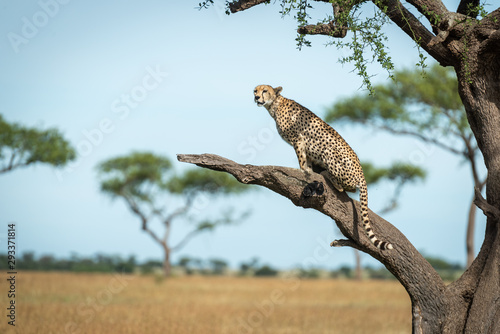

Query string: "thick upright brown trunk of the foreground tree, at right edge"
[455, 37, 500, 333]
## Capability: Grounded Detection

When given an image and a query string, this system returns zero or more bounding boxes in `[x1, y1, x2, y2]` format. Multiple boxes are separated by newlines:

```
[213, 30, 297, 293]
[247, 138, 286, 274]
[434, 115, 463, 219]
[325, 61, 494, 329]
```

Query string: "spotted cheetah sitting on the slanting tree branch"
[254, 85, 393, 250]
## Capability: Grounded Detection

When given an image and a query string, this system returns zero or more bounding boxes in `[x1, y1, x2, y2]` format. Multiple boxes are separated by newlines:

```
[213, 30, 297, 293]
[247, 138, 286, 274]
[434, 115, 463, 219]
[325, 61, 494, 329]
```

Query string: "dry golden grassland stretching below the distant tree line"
[0, 272, 411, 334]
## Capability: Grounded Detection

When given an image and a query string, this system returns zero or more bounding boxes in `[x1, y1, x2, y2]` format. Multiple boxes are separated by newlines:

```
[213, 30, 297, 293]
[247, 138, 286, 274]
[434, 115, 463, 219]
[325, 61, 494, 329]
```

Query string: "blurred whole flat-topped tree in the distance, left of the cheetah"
[97, 152, 248, 276]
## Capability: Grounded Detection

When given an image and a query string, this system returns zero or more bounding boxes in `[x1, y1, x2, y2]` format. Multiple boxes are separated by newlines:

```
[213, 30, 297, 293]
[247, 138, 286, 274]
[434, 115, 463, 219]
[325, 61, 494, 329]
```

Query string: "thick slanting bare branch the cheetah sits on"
[177, 154, 445, 318]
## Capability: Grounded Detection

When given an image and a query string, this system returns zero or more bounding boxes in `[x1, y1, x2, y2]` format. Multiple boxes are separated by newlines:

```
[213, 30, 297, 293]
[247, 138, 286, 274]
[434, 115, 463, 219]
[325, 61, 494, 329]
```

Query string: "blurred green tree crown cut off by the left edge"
[0, 115, 76, 174]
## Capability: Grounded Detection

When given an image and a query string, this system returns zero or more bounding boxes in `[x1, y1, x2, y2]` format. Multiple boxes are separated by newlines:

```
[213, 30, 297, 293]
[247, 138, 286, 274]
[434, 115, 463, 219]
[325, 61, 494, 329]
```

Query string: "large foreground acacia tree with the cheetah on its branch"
[189, 0, 500, 333]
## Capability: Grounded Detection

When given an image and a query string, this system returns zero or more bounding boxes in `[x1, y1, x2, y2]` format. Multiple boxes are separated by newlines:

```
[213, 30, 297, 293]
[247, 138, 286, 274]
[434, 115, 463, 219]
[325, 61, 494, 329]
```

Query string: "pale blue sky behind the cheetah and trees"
[0, 0, 484, 268]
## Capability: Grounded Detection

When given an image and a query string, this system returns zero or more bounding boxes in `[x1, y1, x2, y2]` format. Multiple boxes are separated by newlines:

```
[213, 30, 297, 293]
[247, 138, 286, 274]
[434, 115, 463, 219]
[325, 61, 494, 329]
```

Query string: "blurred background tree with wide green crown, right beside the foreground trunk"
[326, 64, 486, 267]
